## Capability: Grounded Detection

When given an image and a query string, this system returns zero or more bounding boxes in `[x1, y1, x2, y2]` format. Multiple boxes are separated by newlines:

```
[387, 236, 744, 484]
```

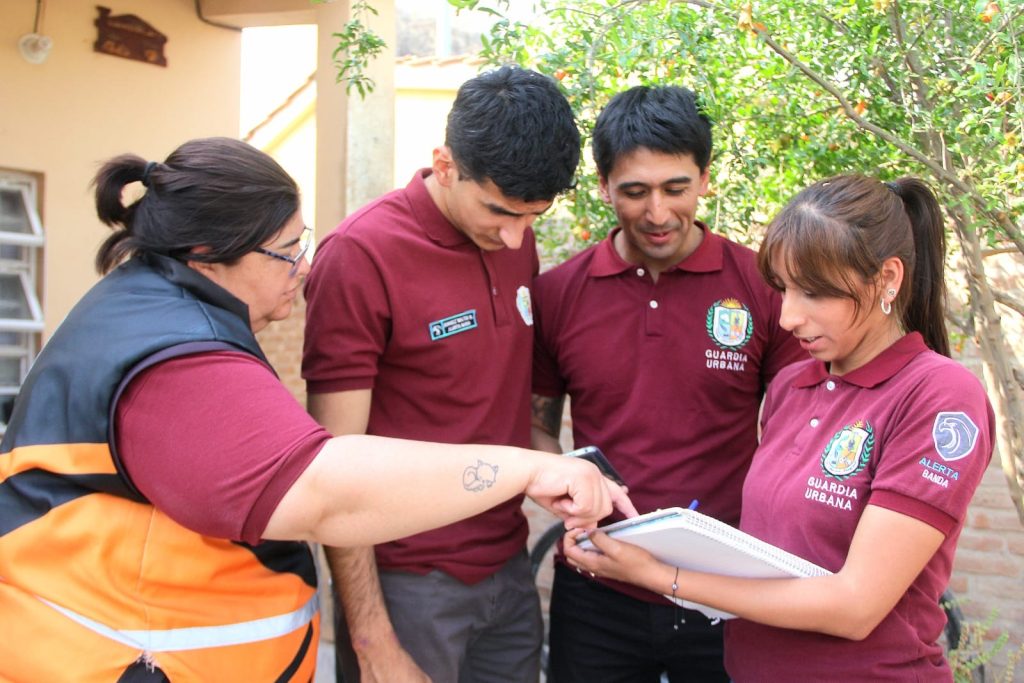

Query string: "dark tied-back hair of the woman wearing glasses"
[93, 137, 299, 273]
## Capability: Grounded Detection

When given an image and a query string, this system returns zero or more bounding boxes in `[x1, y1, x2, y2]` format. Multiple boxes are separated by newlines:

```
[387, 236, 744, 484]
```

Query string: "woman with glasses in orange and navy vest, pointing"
[0, 138, 635, 681]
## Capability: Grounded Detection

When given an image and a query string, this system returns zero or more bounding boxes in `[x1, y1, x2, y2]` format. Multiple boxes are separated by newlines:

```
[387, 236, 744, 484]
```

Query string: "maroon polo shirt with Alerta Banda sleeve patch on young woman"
[726, 333, 995, 681]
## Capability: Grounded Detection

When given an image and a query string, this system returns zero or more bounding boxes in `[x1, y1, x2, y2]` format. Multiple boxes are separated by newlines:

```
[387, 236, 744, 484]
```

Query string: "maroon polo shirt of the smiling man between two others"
[534, 223, 807, 601]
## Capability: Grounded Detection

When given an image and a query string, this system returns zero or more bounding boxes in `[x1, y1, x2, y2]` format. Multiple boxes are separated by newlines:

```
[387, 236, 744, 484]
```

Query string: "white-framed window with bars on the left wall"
[0, 171, 44, 433]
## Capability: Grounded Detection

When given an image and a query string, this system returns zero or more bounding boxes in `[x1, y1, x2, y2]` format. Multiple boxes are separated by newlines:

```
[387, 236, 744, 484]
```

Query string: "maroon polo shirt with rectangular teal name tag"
[302, 170, 538, 583]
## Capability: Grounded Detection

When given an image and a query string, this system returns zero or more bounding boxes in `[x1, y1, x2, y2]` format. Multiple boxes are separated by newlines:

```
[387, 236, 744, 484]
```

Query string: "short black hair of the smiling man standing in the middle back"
[592, 85, 712, 178]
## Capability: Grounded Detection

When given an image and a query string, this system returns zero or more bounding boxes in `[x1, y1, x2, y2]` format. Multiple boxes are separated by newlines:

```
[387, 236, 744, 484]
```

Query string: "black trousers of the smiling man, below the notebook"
[549, 564, 729, 683]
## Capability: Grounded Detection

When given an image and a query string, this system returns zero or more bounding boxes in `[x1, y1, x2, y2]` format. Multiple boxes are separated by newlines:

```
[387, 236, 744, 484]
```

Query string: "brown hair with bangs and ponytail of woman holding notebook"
[758, 174, 949, 355]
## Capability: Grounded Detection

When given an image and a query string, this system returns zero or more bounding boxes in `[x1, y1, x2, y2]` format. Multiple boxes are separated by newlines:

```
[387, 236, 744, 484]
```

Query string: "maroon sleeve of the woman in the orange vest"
[115, 352, 331, 544]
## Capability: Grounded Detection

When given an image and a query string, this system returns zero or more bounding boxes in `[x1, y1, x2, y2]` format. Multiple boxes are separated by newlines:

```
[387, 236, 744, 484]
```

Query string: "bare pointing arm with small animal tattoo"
[263, 434, 636, 546]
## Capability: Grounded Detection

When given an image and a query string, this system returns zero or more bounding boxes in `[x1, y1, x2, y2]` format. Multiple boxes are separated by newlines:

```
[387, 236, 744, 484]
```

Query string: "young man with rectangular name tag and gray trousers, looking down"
[303, 67, 580, 683]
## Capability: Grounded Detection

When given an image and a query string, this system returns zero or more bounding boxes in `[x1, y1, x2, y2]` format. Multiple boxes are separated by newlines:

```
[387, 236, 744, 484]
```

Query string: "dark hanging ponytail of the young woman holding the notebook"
[887, 177, 949, 356]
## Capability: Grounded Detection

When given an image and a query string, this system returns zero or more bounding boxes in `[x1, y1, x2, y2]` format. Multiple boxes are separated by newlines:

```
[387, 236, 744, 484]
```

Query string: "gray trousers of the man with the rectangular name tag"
[335, 550, 544, 683]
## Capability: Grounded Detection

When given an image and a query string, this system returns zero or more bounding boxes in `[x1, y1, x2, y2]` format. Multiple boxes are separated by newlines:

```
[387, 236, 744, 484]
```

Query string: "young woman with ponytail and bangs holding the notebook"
[566, 175, 994, 682]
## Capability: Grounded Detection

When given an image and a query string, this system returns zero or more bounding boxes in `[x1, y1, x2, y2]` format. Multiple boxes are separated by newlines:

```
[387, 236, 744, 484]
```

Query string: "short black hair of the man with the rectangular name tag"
[444, 67, 580, 202]
